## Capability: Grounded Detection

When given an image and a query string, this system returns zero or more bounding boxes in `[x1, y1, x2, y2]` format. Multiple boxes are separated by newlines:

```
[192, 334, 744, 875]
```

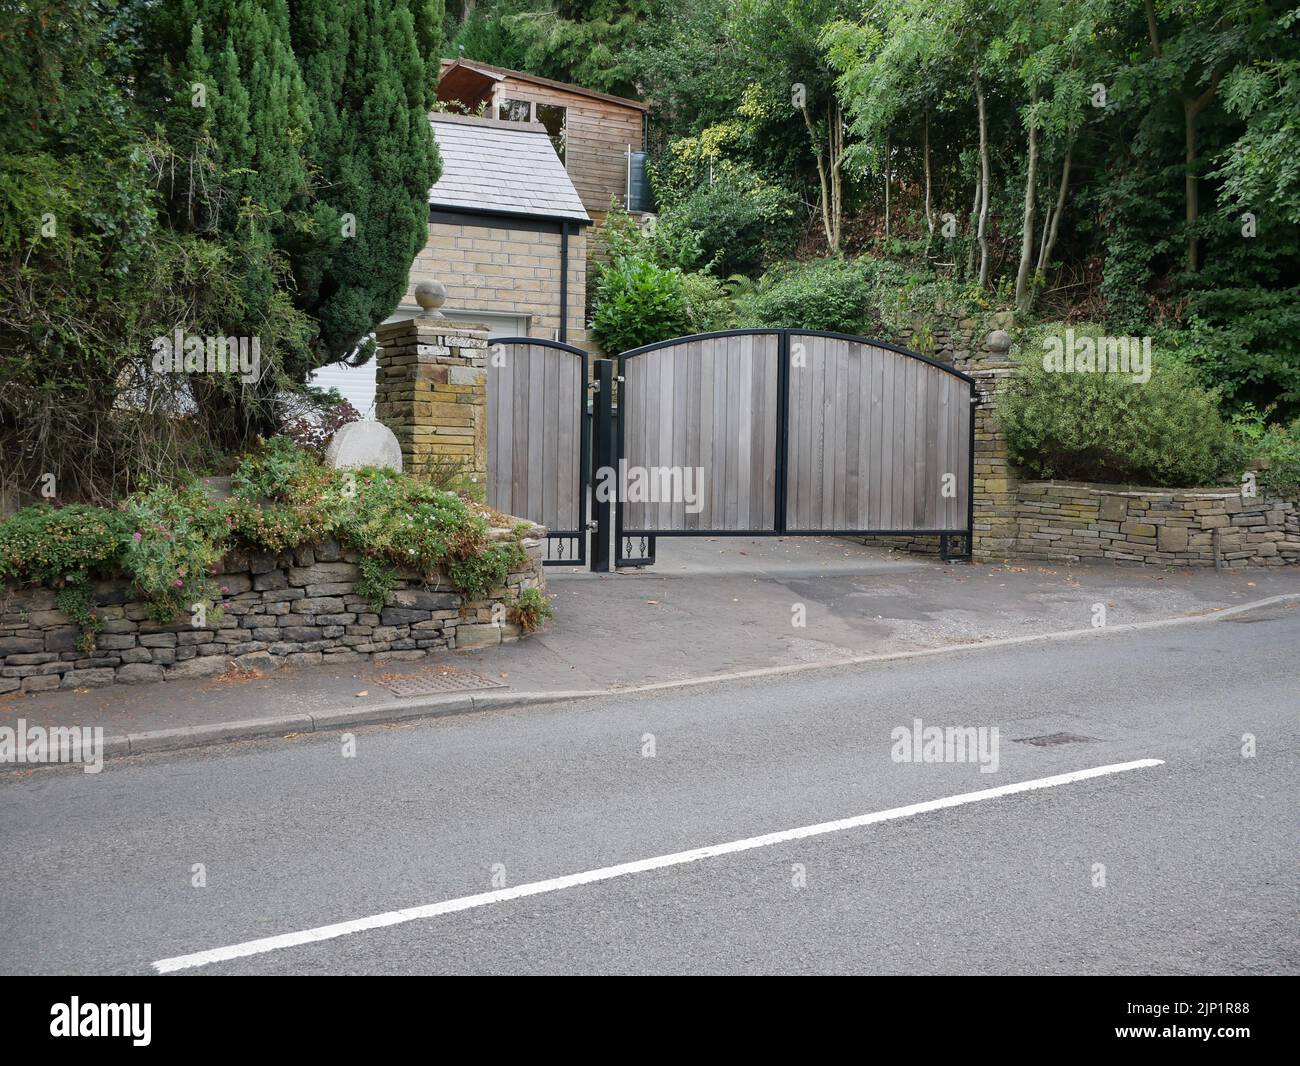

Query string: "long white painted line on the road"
[153, 759, 1165, 974]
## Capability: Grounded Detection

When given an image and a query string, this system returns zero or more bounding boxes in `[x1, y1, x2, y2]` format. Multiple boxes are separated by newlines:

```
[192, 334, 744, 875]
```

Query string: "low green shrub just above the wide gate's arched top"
[740, 259, 872, 333]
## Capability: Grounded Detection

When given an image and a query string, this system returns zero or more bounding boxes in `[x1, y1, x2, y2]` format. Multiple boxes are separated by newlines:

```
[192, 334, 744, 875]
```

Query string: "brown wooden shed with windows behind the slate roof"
[438, 59, 650, 222]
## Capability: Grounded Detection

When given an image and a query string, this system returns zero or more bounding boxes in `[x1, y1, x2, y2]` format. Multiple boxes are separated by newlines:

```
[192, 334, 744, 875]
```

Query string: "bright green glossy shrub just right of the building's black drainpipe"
[592, 257, 690, 352]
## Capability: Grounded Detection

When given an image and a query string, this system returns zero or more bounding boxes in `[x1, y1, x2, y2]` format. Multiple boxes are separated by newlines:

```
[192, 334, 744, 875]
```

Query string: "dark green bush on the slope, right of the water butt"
[667, 168, 800, 276]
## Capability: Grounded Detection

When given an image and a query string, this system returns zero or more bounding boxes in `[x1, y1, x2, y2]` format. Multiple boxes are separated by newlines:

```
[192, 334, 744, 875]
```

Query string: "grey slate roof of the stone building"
[429, 113, 592, 222]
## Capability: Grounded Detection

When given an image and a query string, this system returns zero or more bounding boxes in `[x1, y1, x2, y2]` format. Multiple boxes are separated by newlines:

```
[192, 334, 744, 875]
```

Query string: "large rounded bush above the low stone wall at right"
[998, 346, 1243, 486]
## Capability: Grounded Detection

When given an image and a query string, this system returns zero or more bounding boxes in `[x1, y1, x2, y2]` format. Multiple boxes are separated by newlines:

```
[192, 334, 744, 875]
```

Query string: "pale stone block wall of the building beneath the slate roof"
[403, 220, 588, 347]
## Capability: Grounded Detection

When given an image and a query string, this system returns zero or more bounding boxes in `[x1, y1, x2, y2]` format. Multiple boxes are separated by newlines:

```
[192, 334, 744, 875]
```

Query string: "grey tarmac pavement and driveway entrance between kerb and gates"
[0, 537, 1300, 750]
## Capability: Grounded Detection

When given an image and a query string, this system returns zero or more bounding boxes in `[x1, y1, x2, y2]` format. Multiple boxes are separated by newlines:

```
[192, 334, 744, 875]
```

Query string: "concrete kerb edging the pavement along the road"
[0, 592, 1300, 772]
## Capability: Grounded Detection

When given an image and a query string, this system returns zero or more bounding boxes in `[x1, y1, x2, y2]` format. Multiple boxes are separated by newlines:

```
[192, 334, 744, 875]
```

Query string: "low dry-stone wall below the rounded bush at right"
[1010, 481, 1300, 567]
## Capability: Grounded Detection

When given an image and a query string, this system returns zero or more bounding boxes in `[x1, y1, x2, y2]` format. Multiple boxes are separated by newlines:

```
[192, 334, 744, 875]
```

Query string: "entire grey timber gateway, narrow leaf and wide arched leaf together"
[488, 329, 976, 569]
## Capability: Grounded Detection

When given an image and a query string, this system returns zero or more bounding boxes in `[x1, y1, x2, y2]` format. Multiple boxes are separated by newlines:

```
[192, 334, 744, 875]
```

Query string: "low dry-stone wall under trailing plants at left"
[0, 528, 545, 694]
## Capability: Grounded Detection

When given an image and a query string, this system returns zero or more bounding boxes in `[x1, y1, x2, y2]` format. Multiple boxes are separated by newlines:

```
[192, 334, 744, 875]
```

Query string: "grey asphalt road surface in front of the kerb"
[0, 607, 1300, 974]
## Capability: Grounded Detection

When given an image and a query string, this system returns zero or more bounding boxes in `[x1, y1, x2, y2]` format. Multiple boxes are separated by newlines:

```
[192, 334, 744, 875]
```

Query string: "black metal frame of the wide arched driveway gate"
[592, 329, 979, 571]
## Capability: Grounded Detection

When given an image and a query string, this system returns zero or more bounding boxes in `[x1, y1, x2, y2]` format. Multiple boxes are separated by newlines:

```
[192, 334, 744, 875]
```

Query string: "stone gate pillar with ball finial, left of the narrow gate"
[374, 282, 488, 490]
